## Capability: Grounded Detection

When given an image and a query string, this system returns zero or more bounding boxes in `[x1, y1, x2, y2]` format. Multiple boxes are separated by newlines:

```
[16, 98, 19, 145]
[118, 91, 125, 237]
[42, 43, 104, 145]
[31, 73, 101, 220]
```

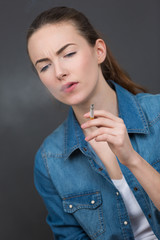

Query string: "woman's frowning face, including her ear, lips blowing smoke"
[28, 23, 105, 106]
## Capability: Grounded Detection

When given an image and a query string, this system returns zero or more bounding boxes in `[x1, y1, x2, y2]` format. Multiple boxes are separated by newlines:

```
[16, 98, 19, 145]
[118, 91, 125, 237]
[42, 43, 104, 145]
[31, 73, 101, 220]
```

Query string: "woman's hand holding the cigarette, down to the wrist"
[81, 110, 135, 166]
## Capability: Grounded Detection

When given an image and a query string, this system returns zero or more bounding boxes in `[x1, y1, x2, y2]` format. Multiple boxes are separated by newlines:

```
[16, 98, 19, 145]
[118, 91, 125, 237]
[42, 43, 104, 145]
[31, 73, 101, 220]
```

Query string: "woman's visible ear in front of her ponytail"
[95, 39, 107, 64]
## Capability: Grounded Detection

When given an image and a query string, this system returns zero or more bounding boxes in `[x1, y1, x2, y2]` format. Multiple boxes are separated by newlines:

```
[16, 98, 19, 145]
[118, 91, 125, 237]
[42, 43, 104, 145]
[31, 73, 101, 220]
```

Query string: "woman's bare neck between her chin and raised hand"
[72, 79, 118, 124]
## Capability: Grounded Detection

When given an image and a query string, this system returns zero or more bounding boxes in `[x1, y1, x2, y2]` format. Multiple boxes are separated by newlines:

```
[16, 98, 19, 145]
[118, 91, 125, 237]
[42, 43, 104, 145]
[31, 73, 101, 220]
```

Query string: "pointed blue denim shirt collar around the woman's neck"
[65, 80, 149, 158]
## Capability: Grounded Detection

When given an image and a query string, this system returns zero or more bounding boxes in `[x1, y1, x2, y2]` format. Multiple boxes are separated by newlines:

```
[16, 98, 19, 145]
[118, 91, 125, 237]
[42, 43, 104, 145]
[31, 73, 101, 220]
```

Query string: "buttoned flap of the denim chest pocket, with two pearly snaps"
[63, 192, 102, 213]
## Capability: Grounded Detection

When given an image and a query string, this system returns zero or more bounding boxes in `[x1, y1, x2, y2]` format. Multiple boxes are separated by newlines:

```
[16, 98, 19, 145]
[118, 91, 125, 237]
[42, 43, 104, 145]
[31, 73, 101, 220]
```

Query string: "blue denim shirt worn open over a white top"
[34, 82, 160, 240]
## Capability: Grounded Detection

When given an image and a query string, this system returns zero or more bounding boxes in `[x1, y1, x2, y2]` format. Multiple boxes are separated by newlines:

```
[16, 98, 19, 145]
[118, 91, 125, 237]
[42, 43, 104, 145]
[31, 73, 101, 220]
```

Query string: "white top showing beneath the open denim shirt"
[112, 176, 158, 240]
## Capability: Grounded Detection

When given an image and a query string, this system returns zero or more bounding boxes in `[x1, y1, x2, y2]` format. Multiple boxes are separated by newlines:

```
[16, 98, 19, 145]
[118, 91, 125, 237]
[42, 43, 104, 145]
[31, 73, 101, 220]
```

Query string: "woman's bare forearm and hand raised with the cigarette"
[81, 111, 160, 211]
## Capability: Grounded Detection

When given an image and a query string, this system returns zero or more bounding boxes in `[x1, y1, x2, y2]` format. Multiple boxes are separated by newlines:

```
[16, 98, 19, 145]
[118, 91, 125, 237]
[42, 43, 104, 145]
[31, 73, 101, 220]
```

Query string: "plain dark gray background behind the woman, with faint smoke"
[0, 0, 160, 240]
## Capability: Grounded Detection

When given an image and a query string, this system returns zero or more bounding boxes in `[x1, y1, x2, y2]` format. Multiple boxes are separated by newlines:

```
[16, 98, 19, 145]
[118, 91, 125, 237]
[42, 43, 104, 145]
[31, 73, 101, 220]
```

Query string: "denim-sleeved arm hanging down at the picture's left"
[34, 151, 89, 240]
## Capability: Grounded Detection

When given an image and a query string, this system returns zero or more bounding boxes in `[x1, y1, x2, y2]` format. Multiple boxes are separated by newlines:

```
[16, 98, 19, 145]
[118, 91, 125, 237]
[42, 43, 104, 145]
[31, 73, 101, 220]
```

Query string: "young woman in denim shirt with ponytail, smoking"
[27, 7, 160, 240]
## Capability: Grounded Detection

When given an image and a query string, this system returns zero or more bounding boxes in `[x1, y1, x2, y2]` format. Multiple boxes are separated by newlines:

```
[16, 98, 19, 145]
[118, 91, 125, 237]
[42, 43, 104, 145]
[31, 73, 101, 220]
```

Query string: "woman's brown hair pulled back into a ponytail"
[27, 7, 146, 94]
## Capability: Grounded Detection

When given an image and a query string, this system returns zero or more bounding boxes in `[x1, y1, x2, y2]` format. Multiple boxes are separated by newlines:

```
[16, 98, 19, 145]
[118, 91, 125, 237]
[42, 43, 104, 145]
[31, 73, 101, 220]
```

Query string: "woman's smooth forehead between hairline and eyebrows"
[28, 22, 85, 57]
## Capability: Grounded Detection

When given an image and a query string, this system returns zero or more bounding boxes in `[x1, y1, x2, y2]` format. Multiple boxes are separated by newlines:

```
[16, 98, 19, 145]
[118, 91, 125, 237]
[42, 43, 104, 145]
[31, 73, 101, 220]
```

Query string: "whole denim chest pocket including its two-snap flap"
[63, 192, 104, 239]
